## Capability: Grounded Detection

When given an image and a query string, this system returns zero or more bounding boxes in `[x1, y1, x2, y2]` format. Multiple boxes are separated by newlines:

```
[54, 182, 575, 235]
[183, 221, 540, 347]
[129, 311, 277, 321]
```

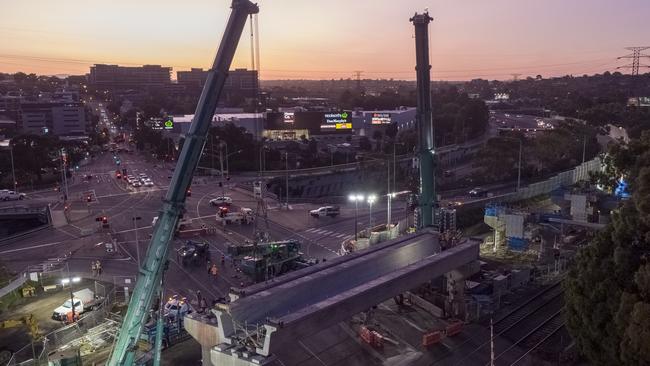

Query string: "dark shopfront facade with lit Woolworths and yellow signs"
[264, 112, 352, 135]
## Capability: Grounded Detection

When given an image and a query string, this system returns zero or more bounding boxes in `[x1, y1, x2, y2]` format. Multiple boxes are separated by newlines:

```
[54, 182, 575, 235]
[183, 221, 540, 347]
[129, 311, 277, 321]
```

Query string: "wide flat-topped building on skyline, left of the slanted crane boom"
[88, 64, 172, 89]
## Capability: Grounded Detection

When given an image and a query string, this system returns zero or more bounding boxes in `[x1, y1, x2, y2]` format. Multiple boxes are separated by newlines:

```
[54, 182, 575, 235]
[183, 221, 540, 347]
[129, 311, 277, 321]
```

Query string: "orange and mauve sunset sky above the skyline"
[0, 0, 650, 80]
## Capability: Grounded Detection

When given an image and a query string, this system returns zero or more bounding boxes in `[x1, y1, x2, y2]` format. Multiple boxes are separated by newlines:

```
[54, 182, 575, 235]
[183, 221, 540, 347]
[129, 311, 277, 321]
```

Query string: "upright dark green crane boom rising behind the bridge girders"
[410, 12, 435, 229]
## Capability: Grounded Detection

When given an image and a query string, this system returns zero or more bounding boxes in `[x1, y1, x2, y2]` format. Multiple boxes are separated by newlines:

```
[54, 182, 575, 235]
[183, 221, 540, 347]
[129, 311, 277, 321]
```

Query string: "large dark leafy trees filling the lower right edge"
[565, 131, 650, 366]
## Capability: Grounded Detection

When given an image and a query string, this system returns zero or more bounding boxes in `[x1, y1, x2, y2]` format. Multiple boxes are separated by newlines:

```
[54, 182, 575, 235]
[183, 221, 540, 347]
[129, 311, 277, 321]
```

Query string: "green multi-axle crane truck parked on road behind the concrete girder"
[228, 240, 316, 282]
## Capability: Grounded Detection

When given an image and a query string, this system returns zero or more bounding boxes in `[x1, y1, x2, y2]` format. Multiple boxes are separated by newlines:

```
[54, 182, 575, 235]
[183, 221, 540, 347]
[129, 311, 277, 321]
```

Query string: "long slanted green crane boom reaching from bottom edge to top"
[107, 0, 259, 366]
